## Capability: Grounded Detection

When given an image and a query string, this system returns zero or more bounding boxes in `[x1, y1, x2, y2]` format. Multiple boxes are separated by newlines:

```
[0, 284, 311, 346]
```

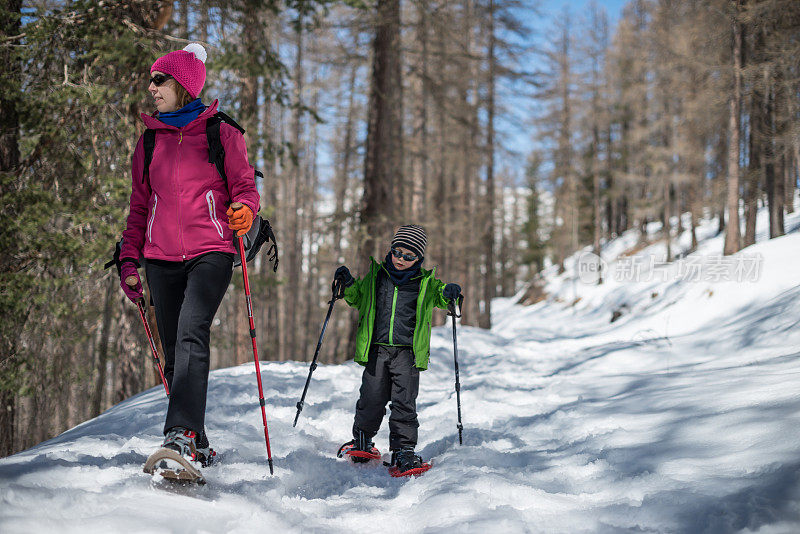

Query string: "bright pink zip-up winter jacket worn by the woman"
[120, 100, 259, 261]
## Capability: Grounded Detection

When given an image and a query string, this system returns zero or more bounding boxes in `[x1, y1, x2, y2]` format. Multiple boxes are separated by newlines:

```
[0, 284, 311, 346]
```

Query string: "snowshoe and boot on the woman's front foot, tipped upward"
[144, 427, 206, 484]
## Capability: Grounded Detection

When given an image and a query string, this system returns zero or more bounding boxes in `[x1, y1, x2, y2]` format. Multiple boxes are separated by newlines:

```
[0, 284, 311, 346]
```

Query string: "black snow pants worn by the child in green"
[353, 344, 419, 451]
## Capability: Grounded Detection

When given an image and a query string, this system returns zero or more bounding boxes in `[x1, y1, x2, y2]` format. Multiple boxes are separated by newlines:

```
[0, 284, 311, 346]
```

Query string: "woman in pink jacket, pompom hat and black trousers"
[120, 43, 259, 478]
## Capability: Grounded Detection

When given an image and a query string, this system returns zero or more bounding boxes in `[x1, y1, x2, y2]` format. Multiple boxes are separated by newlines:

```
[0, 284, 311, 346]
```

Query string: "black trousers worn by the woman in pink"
[145, 252, 233, 440]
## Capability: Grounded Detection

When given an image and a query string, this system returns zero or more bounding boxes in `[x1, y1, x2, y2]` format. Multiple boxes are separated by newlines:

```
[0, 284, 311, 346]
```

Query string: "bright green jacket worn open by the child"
[344, 258, 447, 370]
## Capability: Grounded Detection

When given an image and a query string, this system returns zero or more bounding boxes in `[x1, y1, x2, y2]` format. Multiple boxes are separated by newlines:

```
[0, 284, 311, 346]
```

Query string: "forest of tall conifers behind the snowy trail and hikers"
[0, 0, 800, 456]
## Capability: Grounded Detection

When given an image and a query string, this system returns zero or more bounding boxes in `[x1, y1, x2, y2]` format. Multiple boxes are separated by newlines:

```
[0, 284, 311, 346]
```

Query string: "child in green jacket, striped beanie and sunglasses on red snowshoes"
[334, 224, 461, 474]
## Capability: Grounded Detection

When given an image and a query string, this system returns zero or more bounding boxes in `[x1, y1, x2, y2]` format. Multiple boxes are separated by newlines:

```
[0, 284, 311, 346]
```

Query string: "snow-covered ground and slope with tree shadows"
[0, 203, 800, 534]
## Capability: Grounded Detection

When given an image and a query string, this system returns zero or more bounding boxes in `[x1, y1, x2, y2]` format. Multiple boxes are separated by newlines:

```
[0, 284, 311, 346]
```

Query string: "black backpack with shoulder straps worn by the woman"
[142, 111, 278, 272]
